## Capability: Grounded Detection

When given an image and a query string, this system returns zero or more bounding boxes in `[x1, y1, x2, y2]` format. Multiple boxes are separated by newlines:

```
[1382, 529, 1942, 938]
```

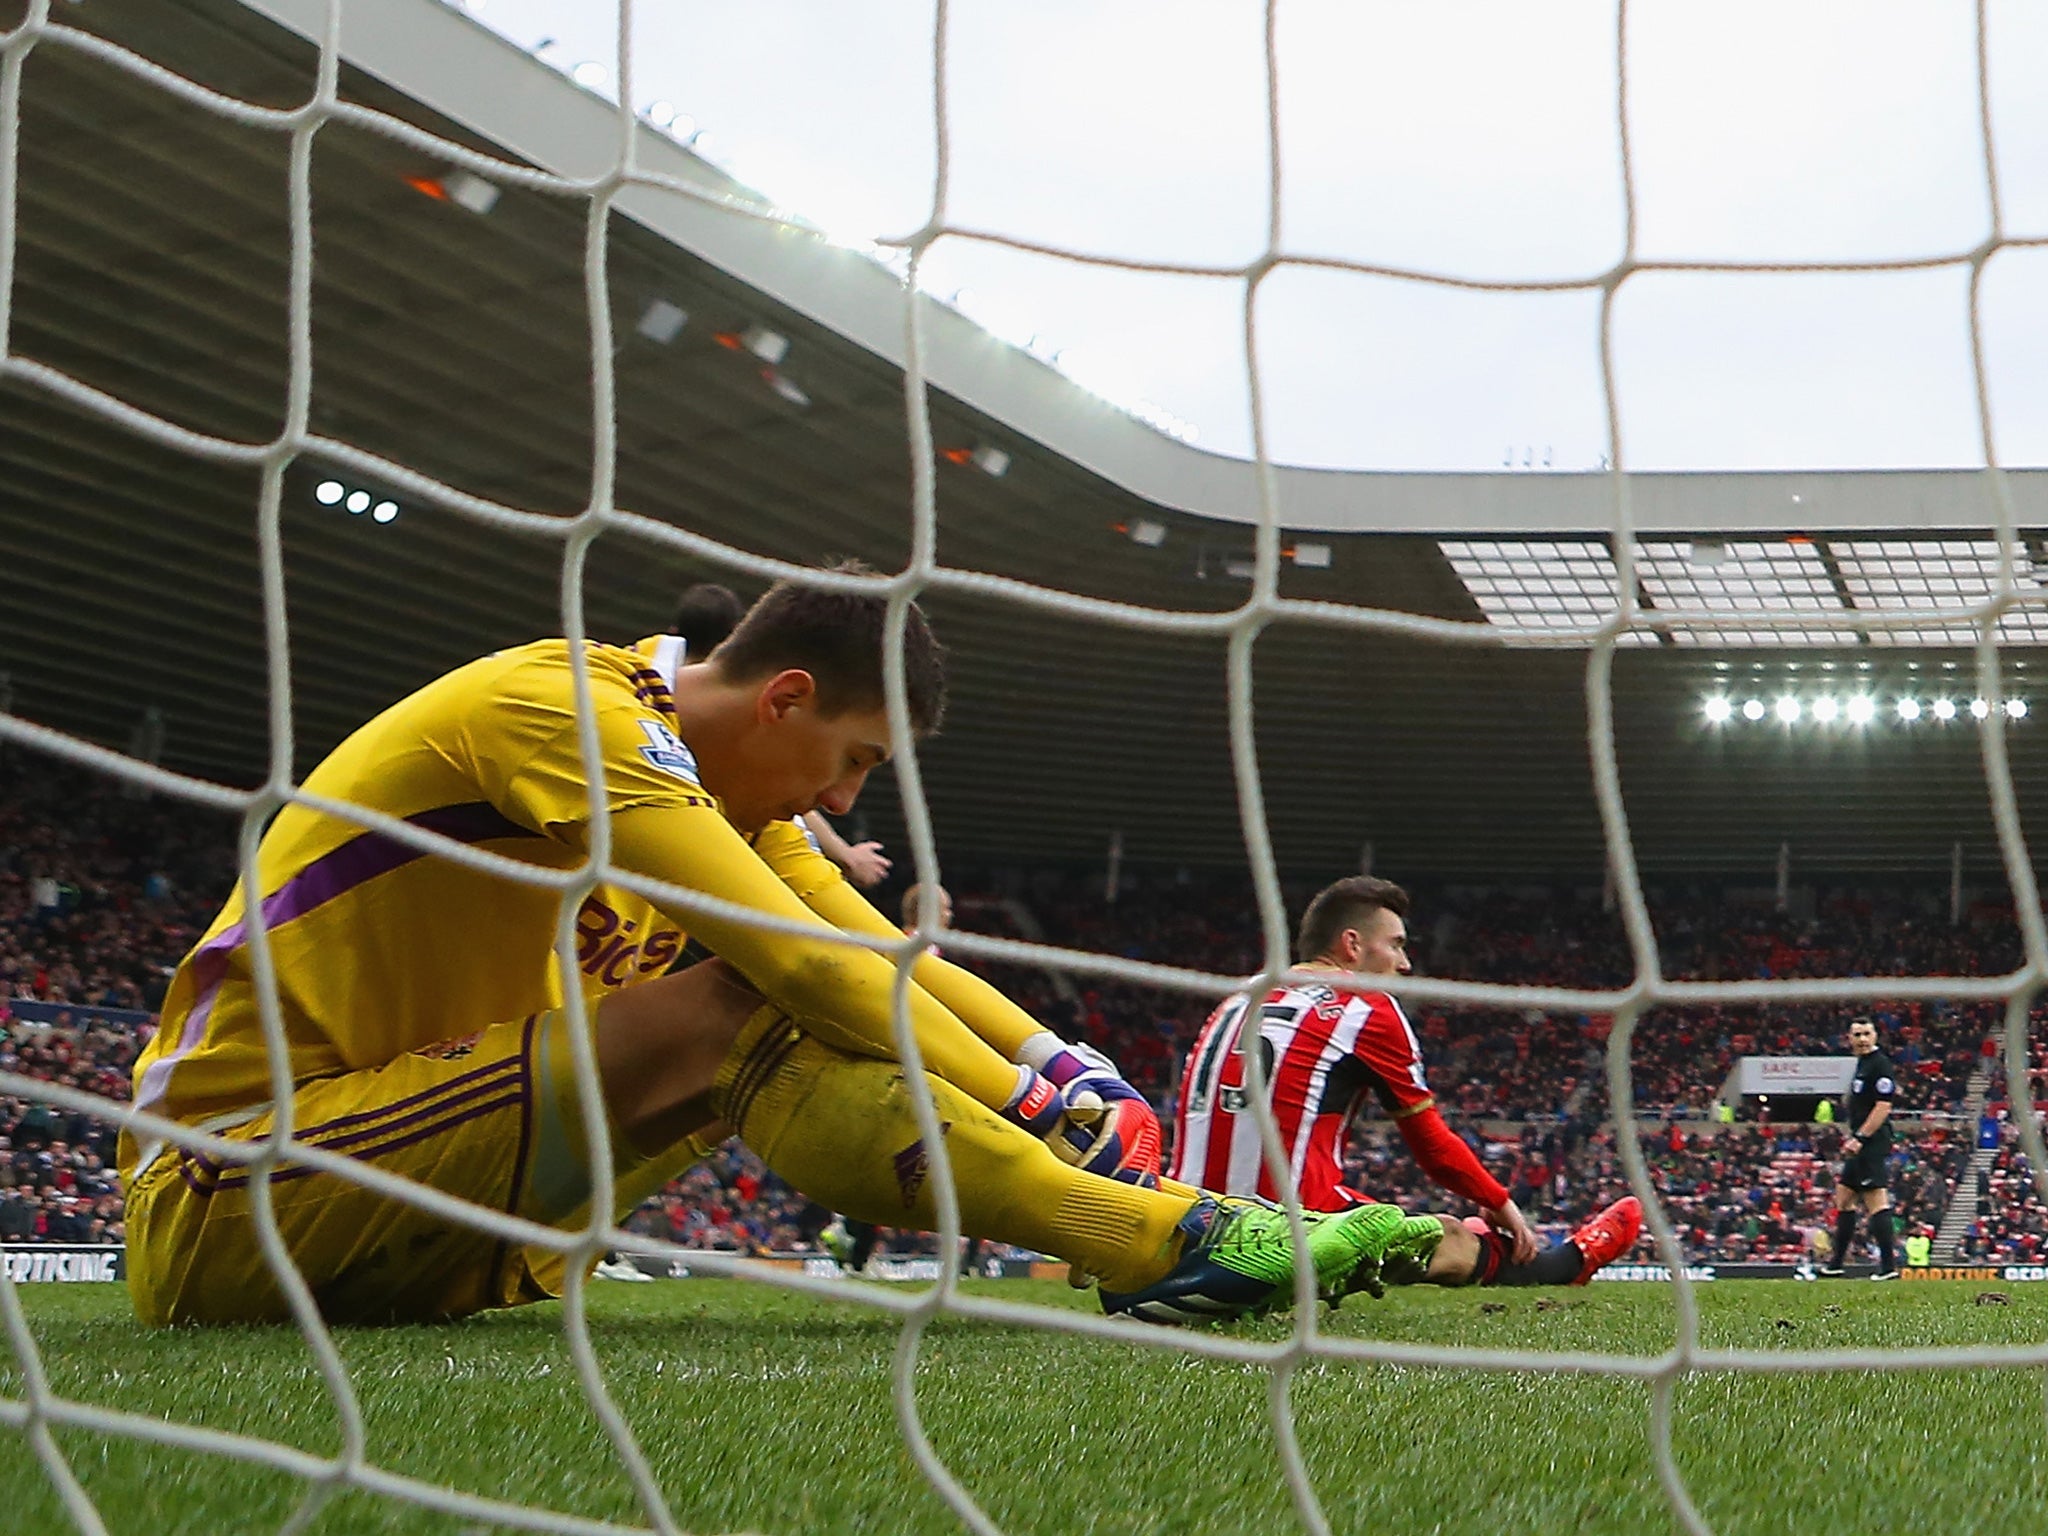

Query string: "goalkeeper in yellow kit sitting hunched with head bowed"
[121, 584, 1440, 1323]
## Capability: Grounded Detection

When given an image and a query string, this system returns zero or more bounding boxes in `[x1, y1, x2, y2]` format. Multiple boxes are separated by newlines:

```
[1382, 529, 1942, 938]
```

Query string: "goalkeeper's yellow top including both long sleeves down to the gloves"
[121, 635, 1036, 1174]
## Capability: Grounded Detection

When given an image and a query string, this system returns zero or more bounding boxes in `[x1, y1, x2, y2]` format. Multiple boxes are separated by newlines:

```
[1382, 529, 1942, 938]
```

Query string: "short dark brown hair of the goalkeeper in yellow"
[713, 559, 946, 735]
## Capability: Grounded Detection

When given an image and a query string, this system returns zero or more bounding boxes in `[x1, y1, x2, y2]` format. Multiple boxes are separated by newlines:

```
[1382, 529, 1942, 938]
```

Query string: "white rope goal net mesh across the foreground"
[0, 0, 2048, 1536]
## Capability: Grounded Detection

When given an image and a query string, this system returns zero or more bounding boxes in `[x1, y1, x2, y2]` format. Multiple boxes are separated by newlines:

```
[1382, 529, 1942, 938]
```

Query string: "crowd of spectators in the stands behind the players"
[0, 752, 2048, 1262]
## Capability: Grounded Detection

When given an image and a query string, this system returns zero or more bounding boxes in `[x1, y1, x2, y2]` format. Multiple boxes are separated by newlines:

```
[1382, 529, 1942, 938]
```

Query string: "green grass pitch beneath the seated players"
[0, 1280, 2048, 1536]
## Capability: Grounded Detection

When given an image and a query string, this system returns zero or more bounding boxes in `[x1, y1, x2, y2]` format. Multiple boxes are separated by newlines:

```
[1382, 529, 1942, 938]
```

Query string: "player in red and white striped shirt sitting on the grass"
[1169, 874, 1642, 1284]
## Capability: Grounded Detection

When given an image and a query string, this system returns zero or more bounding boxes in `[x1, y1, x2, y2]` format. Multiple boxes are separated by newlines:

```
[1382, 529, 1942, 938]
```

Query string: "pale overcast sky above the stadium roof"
[448, 0, 2048, 469]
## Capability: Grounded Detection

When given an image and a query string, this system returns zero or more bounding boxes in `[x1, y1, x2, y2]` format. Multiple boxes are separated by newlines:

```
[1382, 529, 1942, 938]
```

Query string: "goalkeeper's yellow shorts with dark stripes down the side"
[127, 1010, 694, 1323]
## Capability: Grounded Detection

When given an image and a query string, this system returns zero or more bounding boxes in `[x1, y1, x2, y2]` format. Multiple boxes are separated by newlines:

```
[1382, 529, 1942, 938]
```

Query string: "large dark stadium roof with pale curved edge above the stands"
[12, 0, 2048, 879]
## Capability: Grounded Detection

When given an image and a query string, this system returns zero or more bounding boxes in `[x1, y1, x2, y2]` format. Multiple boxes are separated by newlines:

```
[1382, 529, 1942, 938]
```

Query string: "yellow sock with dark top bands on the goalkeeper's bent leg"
[713, 1024, 1194, 1290]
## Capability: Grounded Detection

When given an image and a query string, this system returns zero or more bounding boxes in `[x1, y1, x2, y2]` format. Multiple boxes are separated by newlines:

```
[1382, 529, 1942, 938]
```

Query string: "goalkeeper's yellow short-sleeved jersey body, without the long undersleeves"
[135, 637, 720, 1120]
